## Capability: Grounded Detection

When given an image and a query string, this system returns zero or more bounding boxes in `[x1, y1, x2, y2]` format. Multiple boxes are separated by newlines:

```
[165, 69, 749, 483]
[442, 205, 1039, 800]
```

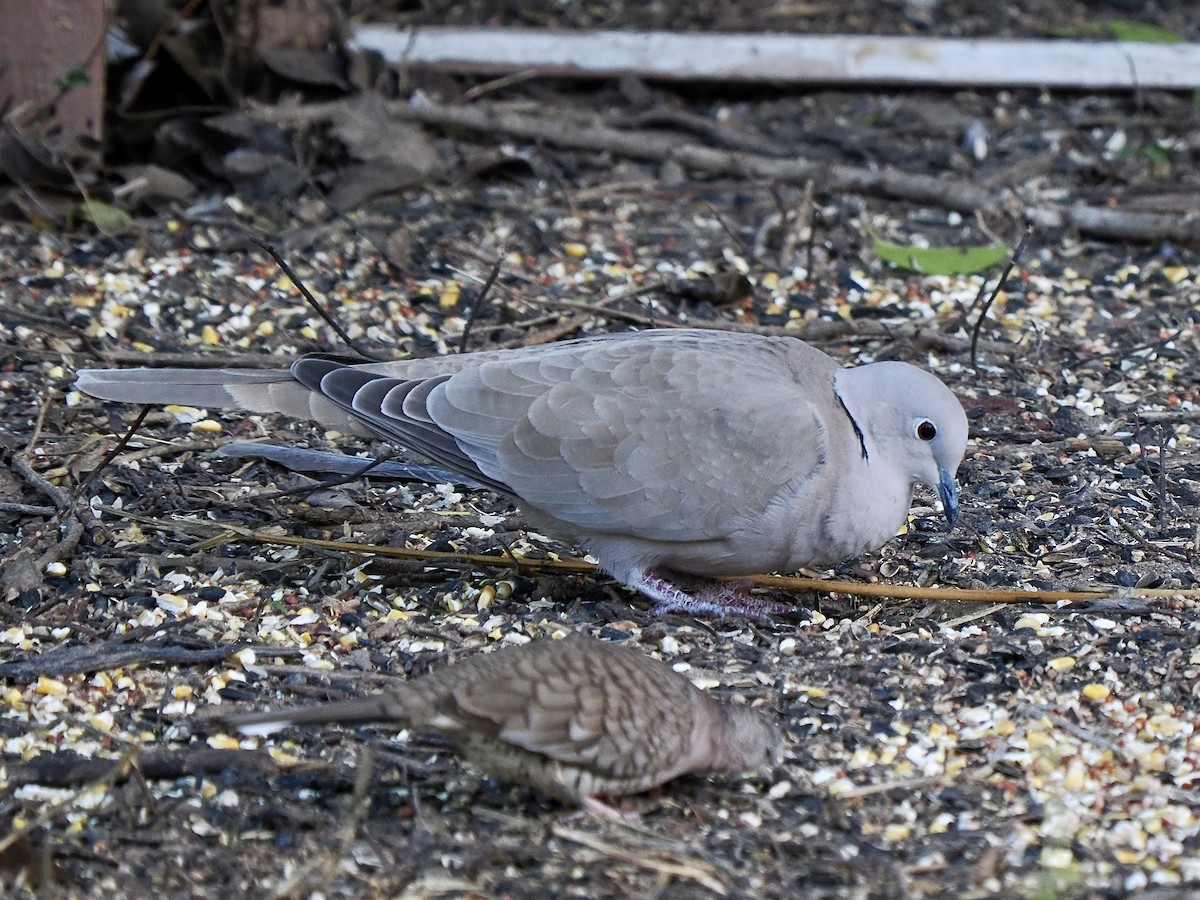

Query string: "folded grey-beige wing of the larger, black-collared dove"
[294, 330, 836, 541]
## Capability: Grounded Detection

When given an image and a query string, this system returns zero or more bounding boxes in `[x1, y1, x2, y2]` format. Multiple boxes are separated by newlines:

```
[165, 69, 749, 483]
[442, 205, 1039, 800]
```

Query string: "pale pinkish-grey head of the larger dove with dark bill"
[834, 362, 967, 524]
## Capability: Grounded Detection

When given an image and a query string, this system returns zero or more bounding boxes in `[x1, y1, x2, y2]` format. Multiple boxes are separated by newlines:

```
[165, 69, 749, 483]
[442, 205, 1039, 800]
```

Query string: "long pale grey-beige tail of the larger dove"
[76, 368, 374, 437]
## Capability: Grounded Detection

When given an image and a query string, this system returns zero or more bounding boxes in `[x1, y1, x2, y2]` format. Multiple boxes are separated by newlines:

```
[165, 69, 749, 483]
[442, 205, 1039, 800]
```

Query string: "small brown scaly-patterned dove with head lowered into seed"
[220, 634, 780, 805]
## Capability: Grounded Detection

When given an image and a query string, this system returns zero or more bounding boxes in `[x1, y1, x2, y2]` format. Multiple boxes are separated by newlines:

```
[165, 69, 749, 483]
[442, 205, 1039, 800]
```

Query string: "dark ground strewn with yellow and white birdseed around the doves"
[0, 4, 1200, 898]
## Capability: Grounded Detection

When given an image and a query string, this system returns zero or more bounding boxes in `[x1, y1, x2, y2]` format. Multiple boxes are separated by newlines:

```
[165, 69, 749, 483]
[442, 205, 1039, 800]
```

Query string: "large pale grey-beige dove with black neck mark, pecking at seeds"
[77, 329, 967, 616]
